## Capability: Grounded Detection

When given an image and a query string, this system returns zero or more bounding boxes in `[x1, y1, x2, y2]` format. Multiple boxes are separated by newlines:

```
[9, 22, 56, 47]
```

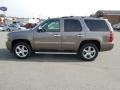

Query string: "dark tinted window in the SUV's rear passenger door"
[64, 19, 82, 32]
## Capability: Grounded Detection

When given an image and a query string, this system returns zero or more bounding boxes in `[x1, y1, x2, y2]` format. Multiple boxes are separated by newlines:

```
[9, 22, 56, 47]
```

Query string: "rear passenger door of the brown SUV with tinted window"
[62, 19, 84, 50]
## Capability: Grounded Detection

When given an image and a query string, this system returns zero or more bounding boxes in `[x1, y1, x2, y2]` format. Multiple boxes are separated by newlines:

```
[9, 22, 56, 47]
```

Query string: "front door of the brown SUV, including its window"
[34, 19, 61, 50]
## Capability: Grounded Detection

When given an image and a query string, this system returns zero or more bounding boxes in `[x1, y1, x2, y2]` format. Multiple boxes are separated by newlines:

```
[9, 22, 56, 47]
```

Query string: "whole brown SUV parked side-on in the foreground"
[6, 17, 114, 61]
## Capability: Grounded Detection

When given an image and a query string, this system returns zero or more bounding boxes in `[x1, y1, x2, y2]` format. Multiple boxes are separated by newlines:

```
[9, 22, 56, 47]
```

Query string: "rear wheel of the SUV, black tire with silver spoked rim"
[78, 43, 99, 61]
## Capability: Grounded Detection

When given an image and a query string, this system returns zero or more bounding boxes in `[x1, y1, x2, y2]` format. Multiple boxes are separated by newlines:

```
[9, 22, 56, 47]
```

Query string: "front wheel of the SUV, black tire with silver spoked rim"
[13, 42, 32, 59]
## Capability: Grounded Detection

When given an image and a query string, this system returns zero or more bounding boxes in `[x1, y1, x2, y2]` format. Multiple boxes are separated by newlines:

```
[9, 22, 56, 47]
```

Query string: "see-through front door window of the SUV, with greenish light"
[42, 20, 60, 32]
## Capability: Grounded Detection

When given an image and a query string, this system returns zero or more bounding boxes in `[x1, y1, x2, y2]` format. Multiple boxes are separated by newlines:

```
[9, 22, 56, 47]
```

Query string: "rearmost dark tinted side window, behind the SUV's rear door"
[85, 20, 109, 31]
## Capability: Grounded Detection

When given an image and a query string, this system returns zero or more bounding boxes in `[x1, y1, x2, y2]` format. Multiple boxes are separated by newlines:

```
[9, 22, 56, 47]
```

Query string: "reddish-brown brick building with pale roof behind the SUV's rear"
[95, 10, 120, 25]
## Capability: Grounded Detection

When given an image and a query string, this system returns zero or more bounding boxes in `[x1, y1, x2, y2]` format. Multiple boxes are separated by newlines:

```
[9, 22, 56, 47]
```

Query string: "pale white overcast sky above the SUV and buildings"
[0, 0, 120, 18]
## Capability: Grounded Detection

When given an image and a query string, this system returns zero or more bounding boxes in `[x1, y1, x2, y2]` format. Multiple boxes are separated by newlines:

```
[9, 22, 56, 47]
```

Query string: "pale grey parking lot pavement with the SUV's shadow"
[0, 32, 120, 90]
